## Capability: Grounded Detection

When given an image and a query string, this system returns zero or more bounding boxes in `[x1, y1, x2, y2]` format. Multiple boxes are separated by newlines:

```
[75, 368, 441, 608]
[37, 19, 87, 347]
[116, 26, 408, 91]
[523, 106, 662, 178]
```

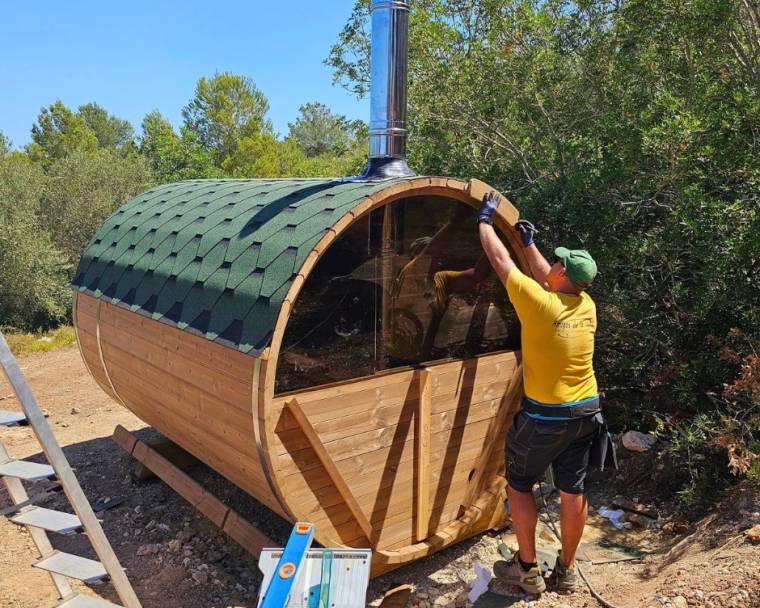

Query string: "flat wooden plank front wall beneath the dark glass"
[272, 352, 517, 550]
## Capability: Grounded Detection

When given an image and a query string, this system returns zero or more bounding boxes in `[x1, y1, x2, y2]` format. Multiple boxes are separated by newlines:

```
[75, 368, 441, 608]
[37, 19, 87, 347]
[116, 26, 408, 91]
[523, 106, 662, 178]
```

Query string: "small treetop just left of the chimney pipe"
[288, 102, 362, 157]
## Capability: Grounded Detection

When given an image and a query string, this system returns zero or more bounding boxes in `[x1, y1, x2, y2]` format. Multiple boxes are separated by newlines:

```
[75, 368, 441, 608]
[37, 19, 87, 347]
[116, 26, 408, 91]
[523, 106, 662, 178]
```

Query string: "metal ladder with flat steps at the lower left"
[0, 333, 141, 608]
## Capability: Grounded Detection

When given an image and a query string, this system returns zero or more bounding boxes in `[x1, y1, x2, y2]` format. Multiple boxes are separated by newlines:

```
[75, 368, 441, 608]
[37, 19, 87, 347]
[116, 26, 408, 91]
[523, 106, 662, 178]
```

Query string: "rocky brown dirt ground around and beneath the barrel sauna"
[0, 348, 760, 608]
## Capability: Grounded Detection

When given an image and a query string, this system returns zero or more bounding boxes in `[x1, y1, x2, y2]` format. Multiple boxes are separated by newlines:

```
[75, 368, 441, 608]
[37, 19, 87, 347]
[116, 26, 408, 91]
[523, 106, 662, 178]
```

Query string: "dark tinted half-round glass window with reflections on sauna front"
[276, 196, 519, 393]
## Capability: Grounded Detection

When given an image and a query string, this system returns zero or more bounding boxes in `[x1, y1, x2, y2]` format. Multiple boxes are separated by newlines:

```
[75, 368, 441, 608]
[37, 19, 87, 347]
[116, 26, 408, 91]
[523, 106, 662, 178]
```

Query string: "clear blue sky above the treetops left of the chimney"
[0, 0, 369, 147]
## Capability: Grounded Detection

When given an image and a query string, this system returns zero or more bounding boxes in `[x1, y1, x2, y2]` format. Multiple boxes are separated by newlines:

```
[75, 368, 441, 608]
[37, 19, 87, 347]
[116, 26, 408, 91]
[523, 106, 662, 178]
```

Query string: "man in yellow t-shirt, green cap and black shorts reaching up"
[478, 192, 603, 593]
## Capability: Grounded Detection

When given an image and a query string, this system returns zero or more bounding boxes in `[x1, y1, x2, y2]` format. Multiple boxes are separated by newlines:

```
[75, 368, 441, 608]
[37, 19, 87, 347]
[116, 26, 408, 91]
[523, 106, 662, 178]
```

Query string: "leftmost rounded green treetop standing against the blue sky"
[27, 100, 98, 160]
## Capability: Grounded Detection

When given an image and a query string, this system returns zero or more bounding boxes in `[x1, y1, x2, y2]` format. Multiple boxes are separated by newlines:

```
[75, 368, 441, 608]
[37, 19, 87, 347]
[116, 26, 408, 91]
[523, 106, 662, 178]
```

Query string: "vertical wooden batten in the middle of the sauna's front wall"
[414, 369, 433, 542]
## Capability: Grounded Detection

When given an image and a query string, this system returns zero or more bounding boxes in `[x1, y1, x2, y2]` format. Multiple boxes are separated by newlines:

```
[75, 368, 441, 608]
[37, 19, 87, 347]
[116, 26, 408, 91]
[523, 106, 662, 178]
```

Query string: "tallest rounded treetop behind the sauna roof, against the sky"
[182, 72, 272, 167]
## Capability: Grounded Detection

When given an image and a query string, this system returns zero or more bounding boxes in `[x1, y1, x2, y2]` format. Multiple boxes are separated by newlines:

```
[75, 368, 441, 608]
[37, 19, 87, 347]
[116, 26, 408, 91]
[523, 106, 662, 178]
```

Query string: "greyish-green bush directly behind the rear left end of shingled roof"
[41, 150, 155, 265]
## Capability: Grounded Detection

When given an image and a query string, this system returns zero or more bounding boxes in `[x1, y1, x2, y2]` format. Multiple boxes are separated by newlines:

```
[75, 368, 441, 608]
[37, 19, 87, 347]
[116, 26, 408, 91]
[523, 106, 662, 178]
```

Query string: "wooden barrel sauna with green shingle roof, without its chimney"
[73, 177, 528, 574]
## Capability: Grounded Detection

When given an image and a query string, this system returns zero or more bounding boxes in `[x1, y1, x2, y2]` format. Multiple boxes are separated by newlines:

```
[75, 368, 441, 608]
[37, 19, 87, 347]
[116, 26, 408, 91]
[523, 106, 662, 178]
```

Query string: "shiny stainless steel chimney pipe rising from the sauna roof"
[362, 0, 415, 179]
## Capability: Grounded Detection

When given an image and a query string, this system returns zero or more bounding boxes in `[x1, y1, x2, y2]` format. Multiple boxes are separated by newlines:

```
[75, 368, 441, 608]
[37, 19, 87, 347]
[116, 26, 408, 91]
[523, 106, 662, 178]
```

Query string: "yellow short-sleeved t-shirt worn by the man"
[507, 268, 597, 404]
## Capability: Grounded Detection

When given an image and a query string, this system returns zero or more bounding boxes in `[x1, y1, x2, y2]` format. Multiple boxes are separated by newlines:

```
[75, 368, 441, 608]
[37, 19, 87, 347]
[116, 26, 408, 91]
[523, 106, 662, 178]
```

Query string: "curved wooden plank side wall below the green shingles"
[77, 294, 281, 513]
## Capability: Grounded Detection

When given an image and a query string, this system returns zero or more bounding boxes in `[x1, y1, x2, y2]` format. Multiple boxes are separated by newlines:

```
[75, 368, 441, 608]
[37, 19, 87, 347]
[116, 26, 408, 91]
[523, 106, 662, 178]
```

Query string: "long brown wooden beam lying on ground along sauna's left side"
[111, 425, 277, 557]
